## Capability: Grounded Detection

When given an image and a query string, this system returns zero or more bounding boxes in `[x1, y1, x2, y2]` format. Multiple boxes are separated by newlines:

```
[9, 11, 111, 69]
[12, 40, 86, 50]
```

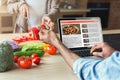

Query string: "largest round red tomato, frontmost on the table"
[18, 56, 32, 69]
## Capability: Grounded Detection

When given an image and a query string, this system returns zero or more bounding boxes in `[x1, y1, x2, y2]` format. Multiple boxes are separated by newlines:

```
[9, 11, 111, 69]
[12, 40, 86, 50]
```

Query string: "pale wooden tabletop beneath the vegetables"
[0, 34, 79, 80]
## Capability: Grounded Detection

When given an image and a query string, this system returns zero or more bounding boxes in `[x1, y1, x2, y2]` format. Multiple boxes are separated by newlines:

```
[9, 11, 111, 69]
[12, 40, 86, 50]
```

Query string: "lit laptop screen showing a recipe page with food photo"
[60, 19, 103, 48]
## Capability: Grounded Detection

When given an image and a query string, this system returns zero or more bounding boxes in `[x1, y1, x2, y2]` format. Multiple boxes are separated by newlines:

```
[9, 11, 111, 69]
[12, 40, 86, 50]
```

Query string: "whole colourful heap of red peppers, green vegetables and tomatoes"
[7, 25, 57, 69]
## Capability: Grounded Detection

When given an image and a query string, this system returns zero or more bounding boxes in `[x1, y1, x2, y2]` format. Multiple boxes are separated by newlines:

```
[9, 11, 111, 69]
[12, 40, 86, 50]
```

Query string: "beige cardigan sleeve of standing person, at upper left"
[7, 0, 26, 14]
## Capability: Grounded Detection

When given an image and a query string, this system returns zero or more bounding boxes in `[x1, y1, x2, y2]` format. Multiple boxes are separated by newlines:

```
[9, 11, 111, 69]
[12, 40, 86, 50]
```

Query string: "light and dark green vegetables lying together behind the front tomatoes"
[13, 43, 45, 57]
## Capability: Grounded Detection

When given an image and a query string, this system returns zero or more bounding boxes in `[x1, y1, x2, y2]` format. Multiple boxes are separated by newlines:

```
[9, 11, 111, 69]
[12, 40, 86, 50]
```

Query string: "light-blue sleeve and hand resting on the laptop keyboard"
[73, 43, 120, 80]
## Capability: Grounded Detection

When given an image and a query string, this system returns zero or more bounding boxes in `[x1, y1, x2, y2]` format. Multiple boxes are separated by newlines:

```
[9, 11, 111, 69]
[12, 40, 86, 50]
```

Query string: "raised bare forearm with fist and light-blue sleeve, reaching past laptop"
[39, 29, 120, 80]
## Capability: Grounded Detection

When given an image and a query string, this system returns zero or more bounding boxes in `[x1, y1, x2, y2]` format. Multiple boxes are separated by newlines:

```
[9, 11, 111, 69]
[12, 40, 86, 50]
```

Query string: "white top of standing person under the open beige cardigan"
[26, 0, 47, 28]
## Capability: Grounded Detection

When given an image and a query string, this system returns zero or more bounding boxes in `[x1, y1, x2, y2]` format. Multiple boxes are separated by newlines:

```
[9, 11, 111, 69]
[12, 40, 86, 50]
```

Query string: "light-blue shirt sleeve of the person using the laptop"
[73, 51, 120, 80]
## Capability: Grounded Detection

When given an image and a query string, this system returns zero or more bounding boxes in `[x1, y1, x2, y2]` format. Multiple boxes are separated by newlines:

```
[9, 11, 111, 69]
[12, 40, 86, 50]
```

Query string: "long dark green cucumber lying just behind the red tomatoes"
[13, 50, 45, 57]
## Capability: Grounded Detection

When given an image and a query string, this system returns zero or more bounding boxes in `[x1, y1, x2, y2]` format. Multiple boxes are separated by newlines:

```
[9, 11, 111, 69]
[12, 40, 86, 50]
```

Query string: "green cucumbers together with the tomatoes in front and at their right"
[13, 43, 57, 69]
